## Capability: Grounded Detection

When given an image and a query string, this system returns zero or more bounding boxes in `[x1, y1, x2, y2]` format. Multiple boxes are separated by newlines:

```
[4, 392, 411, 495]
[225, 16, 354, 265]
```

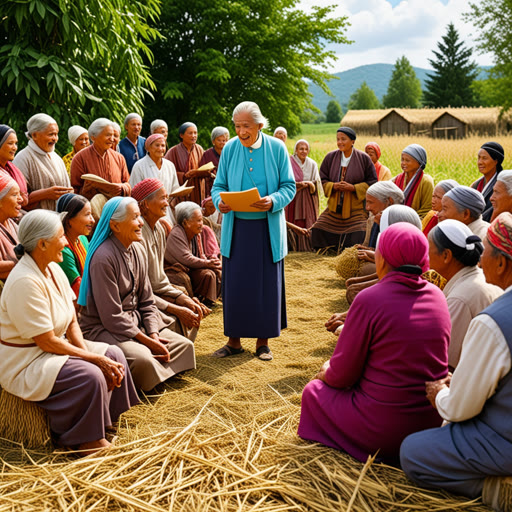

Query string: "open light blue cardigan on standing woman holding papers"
[212, 133, 296, 263]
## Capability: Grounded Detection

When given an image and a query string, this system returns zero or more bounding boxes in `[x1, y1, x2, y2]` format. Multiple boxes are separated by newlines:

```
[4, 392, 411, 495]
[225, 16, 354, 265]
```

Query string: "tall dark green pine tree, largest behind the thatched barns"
[424, 23, 478, 107]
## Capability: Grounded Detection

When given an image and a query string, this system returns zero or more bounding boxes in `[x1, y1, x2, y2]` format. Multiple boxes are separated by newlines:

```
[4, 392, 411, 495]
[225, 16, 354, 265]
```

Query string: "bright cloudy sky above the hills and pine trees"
[301, 0, 492, 72]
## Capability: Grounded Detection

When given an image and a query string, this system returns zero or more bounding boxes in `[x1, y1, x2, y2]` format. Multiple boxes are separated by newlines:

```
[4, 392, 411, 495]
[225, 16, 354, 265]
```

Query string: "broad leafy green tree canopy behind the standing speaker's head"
[145, 0, 347, 142]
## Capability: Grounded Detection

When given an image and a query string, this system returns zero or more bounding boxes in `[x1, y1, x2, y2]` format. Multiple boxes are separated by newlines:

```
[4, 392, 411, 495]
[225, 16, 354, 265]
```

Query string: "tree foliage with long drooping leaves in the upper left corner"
[0, 0, 160, 138]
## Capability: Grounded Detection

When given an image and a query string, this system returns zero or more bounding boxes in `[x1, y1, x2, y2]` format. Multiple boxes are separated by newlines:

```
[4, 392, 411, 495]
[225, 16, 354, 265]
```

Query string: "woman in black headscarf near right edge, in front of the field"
[471, 142, 505, 222]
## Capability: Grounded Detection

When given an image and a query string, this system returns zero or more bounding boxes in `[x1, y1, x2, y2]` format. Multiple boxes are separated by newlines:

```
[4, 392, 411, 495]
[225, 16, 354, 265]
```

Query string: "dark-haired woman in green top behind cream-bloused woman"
[57, 194, 95, 297]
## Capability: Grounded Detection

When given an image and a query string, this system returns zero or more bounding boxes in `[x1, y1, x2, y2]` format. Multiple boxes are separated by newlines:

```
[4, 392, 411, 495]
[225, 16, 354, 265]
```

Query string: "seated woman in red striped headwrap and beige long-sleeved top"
[132, 178, 211, 341]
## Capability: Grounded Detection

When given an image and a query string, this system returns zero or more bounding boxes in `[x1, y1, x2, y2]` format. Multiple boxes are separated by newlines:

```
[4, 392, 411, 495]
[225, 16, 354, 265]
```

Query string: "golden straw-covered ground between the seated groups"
[0, 253, 488, 512]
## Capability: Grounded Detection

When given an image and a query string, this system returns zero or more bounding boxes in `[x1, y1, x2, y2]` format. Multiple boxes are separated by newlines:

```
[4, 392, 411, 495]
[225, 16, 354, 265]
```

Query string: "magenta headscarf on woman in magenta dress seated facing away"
[377, 222, 429, 274]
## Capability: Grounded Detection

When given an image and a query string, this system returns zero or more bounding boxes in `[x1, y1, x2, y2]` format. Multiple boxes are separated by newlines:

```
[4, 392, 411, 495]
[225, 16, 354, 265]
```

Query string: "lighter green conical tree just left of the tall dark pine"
[382, 56, 421, 108]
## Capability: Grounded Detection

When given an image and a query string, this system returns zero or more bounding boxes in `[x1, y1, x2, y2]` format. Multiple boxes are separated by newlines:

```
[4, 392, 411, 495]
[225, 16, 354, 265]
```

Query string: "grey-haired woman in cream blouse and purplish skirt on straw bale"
[0, 210, 139, 454]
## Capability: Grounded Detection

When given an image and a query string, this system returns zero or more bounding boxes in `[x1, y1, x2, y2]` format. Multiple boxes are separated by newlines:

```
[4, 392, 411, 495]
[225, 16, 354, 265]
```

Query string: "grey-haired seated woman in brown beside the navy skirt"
[165, 201, 222, 305]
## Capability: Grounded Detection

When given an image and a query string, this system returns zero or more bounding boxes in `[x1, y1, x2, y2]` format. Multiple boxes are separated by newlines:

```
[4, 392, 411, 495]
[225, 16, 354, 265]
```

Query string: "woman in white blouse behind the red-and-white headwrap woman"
[130, 133, 180, 224]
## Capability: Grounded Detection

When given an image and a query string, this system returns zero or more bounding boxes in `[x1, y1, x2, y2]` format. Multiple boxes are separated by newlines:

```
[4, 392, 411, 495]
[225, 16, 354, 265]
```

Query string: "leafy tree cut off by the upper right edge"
[465, 0, 512, 110]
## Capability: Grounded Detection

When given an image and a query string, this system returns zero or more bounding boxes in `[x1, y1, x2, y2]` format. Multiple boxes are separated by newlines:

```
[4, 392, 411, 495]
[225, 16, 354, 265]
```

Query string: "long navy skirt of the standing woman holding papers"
[222, 218, 287, 338]
